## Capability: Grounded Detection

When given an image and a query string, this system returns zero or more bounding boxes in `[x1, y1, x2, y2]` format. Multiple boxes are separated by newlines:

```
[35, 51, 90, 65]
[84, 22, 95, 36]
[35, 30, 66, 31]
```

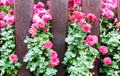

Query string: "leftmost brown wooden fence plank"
[14, 0, 33, 76]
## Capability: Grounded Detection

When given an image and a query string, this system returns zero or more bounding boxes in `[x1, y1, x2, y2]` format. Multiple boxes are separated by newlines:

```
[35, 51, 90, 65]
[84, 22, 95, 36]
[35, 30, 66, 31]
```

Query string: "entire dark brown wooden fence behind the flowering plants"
[14, 0, 120, 76]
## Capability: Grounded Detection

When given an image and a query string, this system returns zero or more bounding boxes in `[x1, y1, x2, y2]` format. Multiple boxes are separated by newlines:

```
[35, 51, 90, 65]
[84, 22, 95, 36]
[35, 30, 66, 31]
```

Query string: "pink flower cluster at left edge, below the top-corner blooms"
[0, 9, 15, 28]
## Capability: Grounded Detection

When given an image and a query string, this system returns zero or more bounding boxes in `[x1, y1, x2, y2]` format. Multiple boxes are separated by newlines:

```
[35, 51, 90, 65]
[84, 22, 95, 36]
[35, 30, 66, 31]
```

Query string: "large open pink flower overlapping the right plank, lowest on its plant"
[86, 35, 98, 46]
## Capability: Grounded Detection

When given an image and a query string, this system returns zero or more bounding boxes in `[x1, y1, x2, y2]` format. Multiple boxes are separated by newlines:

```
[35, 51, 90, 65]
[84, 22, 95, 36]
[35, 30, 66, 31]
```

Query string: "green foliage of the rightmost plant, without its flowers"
[100, 17, 120, 76]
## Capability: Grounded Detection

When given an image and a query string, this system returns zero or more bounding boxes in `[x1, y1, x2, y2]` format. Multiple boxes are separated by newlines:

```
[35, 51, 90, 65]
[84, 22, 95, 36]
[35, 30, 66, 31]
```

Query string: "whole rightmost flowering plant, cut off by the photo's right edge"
[100, 0, 120, 76]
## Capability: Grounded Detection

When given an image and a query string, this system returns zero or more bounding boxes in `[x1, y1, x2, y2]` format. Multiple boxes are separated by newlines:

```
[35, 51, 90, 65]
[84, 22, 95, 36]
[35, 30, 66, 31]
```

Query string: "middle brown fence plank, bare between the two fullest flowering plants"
[50, 0, 68, 76]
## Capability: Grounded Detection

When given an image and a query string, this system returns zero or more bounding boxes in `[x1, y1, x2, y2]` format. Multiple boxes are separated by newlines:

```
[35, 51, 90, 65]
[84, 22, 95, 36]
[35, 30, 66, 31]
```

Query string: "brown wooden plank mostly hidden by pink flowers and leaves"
[82, 0, 101, 76]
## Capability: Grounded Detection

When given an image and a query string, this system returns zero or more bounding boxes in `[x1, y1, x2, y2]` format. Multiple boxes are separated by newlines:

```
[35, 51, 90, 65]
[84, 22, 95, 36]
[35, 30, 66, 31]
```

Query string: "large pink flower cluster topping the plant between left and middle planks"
[29, 2, 52, 36]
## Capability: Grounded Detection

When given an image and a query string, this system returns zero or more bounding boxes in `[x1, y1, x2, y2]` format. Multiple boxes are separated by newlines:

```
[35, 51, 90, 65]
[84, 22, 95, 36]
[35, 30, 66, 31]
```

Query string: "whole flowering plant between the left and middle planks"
[24, 2, 60, 76]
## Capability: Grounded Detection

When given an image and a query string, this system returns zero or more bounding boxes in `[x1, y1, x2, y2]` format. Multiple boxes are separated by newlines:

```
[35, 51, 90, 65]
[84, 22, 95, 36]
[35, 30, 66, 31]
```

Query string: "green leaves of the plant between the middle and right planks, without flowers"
[63, 23, 99, 76]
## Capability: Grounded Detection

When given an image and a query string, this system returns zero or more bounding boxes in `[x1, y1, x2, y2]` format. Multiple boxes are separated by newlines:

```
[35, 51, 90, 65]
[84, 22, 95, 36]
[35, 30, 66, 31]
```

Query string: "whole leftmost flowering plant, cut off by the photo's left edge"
[0, 0, 21, 76]
